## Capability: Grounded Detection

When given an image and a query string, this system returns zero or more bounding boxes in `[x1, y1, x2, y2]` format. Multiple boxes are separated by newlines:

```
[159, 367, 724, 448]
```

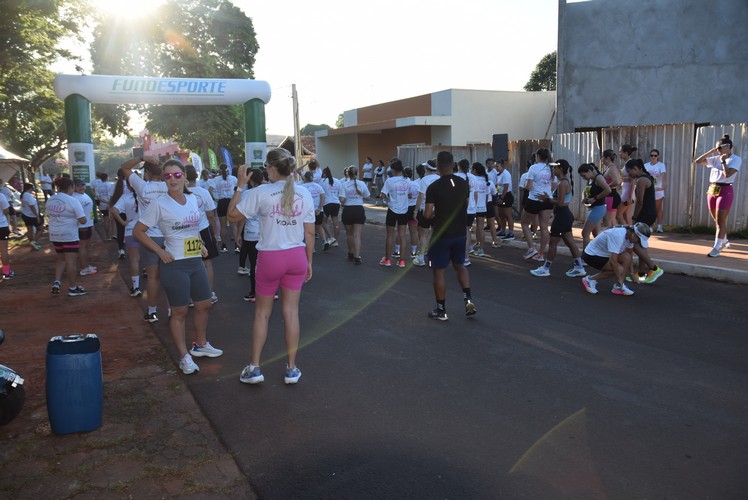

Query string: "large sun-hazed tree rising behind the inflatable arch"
[91, 0, 259, 160]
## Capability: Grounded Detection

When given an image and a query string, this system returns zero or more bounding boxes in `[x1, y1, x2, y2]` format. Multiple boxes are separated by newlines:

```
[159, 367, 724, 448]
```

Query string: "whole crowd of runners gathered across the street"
[0, 135, 741, 384]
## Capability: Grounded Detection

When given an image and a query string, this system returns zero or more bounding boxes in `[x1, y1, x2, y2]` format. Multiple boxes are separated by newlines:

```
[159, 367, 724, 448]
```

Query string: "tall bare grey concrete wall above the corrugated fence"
[556, 0, 748, 133]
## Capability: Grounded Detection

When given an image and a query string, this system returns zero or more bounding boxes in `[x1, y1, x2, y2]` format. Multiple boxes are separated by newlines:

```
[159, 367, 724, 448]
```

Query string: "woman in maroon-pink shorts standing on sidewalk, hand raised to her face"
[695, 134, 743, 257]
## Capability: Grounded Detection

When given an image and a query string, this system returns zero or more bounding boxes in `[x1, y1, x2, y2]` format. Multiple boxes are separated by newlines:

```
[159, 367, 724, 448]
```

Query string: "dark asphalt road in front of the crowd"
[145, 225, 748, 499]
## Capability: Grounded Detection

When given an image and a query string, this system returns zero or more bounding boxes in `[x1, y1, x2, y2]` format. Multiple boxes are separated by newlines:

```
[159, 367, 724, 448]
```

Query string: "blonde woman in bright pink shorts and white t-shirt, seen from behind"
[228, 148, 315, 384]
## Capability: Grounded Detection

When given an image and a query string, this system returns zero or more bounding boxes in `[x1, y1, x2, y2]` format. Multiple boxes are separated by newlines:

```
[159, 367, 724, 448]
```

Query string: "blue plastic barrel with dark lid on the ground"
[47, 334, 104, 434]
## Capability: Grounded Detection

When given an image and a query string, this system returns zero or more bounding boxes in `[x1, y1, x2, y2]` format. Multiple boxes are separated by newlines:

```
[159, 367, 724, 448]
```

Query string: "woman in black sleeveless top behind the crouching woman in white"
[626, 159, 663, 284]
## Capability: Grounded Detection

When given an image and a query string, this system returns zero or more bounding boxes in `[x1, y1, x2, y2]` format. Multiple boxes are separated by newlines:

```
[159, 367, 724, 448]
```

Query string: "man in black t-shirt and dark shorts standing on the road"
[423, 151, 476, 321]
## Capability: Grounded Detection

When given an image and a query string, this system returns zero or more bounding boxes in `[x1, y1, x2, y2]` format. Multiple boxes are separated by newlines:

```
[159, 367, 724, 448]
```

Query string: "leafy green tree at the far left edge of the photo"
[0, 0, 85, 168]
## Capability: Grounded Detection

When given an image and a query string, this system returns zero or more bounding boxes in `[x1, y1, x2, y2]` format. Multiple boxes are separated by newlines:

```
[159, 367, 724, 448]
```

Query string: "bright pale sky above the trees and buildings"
[68, 0, 559, 135]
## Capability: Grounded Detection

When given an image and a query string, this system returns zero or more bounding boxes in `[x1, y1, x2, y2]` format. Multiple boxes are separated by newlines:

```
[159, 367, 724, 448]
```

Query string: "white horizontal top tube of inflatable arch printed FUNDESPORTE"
[54, 74, 270, 105]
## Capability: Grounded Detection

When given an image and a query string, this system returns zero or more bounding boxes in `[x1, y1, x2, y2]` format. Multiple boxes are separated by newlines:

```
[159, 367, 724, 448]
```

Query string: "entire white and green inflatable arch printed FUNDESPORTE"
[54, 74, 270, 183]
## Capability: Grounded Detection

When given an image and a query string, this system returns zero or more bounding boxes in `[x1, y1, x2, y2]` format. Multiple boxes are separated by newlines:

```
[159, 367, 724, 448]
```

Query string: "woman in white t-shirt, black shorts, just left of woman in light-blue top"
[520, 148, 553, 262]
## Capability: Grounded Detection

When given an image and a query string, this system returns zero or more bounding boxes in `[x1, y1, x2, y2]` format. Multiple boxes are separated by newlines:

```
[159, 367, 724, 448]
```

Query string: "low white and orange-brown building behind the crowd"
[316, 89, 556, 175]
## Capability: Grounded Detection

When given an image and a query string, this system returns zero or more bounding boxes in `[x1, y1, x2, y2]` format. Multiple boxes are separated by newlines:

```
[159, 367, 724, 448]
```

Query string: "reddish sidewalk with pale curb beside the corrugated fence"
[365, 204, 748, 285]
